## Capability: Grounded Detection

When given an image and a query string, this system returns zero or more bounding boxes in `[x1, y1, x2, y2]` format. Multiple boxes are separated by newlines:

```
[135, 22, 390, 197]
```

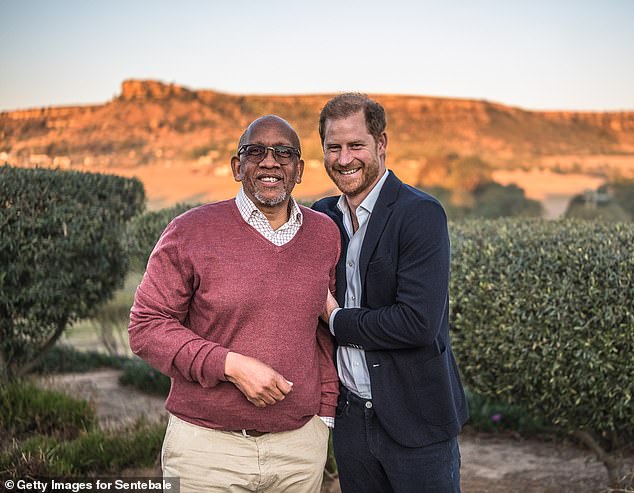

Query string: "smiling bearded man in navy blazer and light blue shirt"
[313, 93, 468, 493]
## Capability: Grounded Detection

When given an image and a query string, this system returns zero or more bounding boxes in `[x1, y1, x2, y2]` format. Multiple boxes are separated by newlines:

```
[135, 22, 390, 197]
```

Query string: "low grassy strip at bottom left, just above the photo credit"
[0, 422, 165, 477]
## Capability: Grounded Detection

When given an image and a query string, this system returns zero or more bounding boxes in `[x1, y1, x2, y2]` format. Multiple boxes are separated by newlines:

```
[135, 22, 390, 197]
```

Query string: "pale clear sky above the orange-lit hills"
[0, 0, 634, 111]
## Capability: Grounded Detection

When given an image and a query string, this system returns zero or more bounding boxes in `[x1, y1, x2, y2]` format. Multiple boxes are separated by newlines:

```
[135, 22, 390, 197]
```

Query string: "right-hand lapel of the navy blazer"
[359, 171, 402, 284]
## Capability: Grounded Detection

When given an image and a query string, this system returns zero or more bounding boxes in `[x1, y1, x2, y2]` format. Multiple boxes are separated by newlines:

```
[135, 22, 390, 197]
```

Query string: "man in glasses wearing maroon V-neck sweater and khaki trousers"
[129, 115, 340, 493]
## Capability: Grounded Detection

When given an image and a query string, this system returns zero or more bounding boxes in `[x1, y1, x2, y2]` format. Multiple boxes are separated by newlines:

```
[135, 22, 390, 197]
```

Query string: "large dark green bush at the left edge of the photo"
[0, 166, 144, 381]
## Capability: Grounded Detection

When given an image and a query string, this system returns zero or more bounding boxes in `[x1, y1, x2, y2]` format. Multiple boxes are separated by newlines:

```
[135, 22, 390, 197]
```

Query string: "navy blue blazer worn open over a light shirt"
[313, 171, 468, 447]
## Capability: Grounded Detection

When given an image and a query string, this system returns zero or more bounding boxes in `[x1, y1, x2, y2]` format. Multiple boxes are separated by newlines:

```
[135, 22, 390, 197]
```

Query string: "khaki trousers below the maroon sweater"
[161, 415, 329, 493]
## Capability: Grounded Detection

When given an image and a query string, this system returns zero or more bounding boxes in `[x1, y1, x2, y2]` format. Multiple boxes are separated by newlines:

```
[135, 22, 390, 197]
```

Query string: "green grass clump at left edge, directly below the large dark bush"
[0, 382, 96, 443]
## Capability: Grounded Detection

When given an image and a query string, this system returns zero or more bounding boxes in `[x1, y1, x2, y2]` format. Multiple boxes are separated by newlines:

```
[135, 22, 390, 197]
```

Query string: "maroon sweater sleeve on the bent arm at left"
[128, 222, 229, 387]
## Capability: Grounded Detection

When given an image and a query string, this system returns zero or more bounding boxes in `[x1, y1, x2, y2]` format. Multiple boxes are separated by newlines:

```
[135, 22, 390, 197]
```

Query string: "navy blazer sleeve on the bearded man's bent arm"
[334, 200, 449, 351]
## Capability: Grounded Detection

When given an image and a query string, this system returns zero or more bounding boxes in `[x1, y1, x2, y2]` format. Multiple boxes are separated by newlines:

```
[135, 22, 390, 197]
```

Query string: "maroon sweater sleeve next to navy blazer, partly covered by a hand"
[317, 227, 341, 417]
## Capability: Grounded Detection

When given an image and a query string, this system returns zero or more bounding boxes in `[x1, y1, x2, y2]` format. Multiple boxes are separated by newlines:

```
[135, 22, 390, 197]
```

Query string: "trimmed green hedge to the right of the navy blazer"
[450, 220, 634, 446]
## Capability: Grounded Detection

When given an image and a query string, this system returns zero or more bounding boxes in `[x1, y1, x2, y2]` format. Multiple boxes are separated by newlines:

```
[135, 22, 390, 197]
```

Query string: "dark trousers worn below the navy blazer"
[333, 388, 460, 493]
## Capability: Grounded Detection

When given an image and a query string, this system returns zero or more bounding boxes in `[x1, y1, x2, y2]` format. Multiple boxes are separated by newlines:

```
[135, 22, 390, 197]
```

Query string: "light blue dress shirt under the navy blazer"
[329, 170, 388, 399]
